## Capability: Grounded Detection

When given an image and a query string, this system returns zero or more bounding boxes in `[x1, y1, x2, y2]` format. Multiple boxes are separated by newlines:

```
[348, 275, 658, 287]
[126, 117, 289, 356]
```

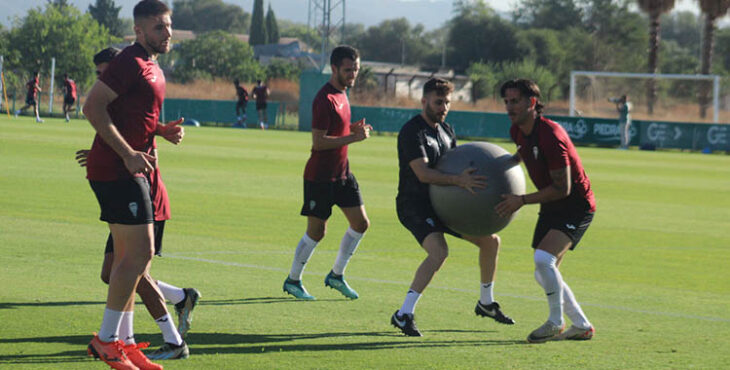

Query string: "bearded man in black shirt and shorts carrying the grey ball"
[390, 78, 515, 337]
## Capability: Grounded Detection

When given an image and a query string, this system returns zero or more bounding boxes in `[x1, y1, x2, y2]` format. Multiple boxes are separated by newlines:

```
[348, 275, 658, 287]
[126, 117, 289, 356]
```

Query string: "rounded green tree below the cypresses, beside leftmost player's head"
[171, 30, 266, 82]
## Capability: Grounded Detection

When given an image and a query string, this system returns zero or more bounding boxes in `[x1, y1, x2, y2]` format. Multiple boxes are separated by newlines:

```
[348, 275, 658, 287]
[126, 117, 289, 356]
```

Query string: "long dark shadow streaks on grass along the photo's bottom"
[0, 330, 527, 364]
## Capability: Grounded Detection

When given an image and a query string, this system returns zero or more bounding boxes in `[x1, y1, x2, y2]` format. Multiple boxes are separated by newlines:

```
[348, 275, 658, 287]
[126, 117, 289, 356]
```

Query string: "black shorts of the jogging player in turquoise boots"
[300, 173, 362, 220]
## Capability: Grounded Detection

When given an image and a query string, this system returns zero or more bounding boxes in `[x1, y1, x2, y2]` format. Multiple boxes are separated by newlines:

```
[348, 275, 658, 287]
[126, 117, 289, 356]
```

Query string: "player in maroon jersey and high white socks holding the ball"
[495, 79, 596, 343]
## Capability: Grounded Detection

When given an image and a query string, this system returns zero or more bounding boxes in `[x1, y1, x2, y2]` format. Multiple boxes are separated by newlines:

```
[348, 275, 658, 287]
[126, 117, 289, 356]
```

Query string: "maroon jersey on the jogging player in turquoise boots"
[304, 82, 350, 182]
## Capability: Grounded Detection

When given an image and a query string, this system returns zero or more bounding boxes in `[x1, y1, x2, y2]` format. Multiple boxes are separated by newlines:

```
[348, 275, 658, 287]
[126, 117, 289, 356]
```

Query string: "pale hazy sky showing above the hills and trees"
[0, 0, 698, 29]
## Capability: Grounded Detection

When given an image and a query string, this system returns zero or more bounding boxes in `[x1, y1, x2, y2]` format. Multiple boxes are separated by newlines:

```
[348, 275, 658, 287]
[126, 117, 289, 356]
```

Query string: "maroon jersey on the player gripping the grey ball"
[510, 116, 596, 212]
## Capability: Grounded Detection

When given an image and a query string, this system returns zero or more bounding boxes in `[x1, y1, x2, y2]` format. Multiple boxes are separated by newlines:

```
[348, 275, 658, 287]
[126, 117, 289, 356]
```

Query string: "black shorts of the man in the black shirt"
[395, 200, 461, 245]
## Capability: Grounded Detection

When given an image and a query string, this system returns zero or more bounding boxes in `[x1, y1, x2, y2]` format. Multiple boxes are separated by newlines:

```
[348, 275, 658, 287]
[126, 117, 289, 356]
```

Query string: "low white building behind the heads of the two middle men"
[361, 61, 472, 102]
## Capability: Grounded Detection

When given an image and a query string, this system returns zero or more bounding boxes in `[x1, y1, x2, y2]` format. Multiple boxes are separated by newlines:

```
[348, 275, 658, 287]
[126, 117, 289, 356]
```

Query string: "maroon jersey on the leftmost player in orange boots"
[86, 43, 165, 181]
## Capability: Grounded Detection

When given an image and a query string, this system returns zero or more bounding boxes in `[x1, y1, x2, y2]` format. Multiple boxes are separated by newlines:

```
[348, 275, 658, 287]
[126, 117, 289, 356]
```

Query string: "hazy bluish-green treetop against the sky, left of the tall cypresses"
[172, 0, 250, 33]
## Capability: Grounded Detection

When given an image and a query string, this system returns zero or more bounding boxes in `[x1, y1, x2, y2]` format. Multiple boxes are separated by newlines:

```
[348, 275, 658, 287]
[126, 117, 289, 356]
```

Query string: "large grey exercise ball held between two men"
[429, 142, 525, 236]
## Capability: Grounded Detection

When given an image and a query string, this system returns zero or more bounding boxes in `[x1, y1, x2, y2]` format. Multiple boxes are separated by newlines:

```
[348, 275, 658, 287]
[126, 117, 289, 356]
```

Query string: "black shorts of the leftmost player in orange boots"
[89, 177, 154, 225]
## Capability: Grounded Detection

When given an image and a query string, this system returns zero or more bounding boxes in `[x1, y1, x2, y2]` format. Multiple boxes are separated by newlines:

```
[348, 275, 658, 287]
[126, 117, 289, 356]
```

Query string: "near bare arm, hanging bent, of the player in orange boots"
[83, 81, 154, 173]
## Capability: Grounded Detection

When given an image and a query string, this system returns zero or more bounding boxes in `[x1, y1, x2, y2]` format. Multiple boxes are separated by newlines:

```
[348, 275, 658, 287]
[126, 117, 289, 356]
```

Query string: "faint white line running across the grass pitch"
[165, 252, 730, 322]
